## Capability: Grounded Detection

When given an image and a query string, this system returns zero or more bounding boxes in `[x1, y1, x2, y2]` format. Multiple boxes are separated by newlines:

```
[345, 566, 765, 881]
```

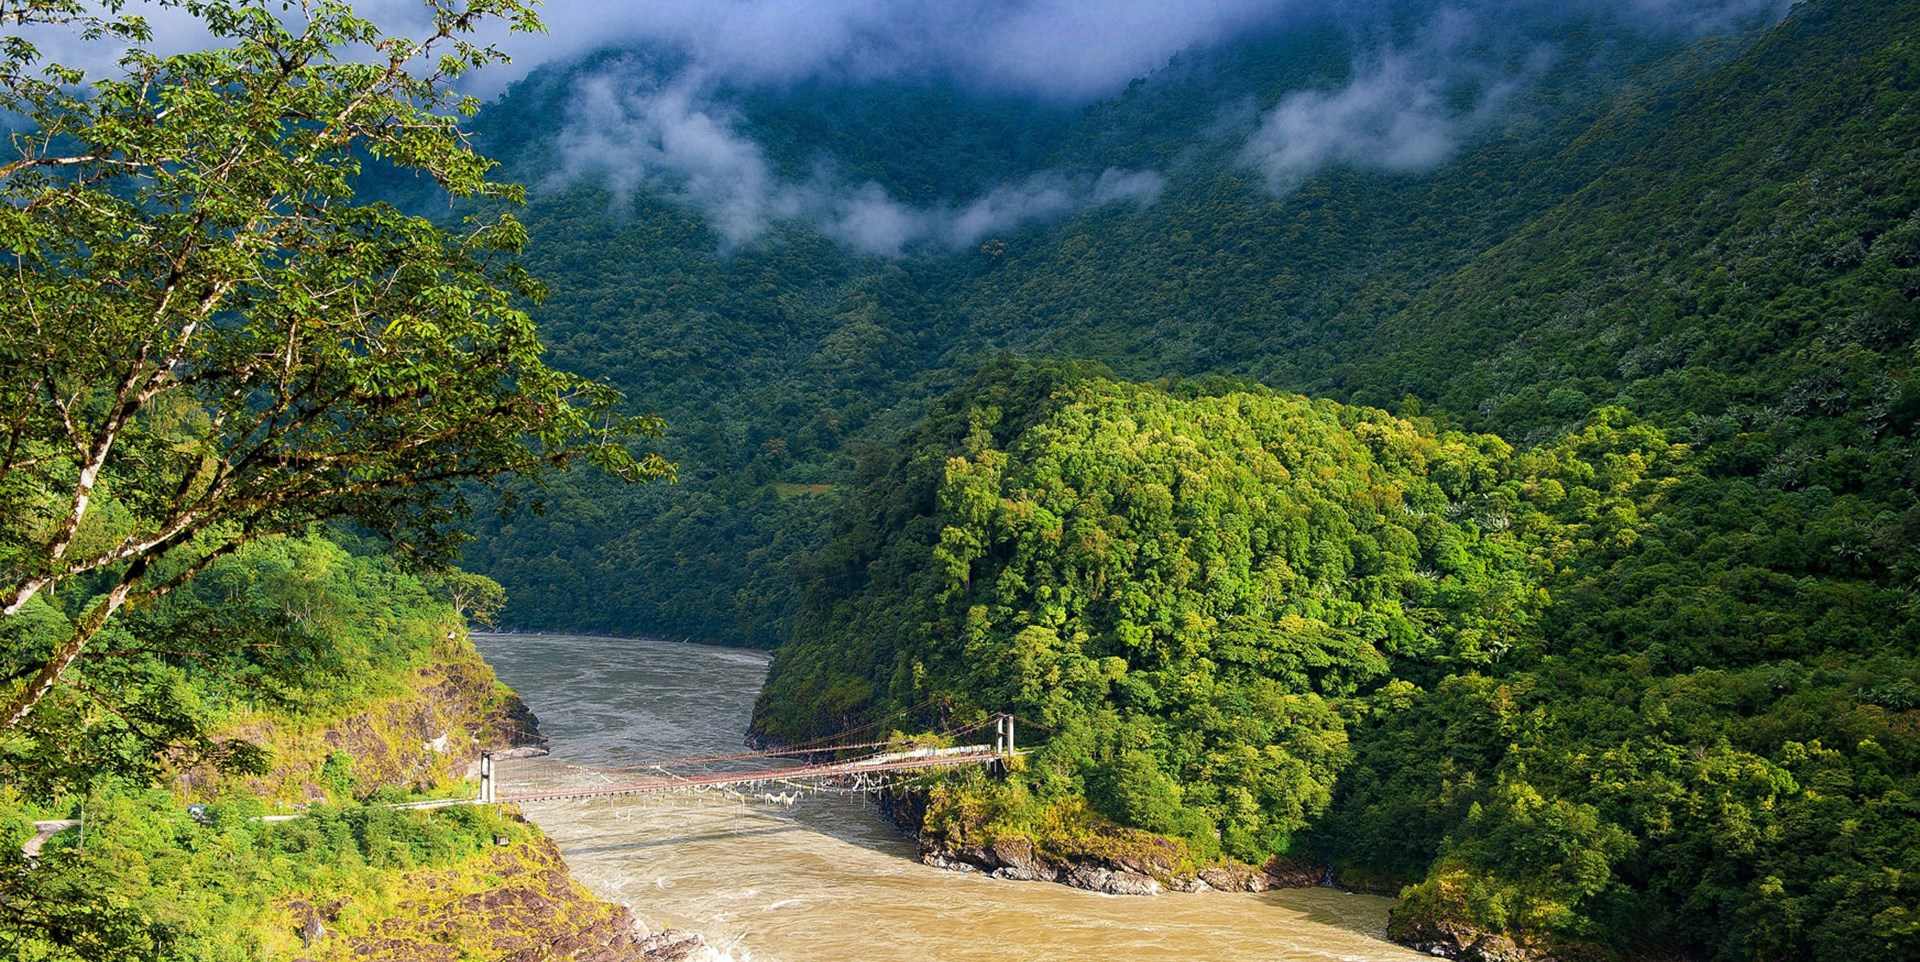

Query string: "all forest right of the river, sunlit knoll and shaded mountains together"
[453, 0, 1920, 960]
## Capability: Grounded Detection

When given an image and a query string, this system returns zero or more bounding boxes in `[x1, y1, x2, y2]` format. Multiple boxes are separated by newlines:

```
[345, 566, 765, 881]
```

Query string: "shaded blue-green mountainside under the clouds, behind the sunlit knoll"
[456, 2, 1774, 647]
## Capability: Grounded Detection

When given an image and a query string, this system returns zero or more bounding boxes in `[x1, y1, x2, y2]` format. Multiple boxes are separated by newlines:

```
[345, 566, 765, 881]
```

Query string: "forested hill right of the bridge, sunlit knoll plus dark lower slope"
[755, 361, 1920, 960]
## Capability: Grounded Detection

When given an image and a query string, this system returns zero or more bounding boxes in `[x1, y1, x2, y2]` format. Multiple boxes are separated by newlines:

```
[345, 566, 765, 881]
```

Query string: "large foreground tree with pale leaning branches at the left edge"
[0, 0, 670, 730]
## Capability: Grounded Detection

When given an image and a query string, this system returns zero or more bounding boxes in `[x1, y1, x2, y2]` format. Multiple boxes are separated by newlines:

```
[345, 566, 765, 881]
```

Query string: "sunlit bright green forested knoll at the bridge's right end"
[756, 363, 1589, 841]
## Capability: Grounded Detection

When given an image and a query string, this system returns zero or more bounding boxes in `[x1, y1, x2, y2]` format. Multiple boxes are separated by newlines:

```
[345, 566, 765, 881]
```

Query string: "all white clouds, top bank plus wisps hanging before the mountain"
[22, 0, 1789, 253]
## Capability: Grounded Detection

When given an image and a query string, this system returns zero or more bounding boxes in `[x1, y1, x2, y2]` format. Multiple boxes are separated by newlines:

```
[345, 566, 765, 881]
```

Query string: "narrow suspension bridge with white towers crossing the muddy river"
[474, 714, 1018, 808]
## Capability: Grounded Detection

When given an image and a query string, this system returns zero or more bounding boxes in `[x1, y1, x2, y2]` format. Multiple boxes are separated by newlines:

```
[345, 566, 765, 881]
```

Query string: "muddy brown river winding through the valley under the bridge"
[474, 634, 1427, 962]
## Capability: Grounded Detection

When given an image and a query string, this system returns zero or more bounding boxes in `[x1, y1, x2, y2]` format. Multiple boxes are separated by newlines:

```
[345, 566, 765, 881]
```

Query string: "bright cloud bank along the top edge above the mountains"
[18, 0, 1791, 100]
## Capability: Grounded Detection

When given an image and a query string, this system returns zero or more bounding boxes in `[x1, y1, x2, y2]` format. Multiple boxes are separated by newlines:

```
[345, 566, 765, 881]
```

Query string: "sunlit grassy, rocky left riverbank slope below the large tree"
[0, 534, 705, 962]
